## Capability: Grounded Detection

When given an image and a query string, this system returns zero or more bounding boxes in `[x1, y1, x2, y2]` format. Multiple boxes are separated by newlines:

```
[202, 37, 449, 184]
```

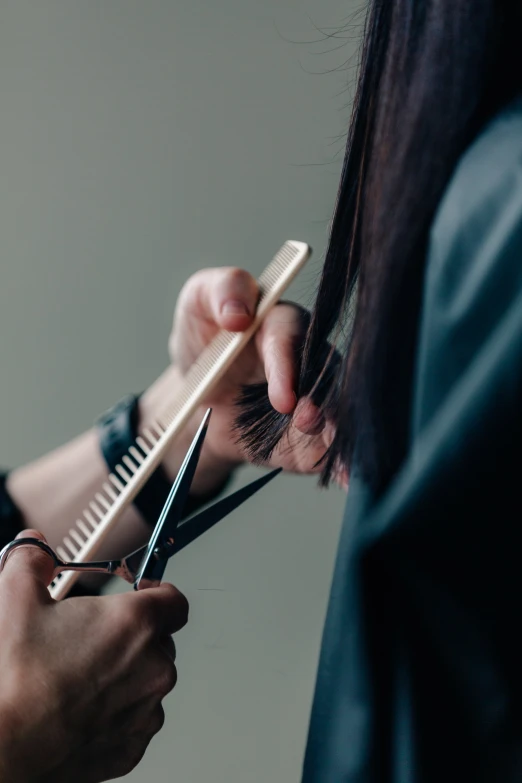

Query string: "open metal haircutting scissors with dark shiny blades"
[0, 408, 282, 590]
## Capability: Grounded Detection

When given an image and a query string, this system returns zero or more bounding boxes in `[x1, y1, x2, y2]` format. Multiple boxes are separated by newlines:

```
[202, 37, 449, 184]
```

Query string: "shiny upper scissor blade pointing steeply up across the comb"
[135, 408, 212, 589]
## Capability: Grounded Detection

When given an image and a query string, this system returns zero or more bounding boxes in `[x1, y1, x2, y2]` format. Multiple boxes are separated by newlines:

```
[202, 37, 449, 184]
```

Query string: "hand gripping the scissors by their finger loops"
[0, 531, 187, 783]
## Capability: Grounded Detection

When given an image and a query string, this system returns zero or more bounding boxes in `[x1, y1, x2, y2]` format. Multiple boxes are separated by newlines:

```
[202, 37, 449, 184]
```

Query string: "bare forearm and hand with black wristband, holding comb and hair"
[7, 268, 325, 554]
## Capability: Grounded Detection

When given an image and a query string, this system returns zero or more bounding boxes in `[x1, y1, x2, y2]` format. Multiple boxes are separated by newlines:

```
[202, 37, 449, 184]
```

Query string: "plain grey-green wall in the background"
[0, 0, 361, 783]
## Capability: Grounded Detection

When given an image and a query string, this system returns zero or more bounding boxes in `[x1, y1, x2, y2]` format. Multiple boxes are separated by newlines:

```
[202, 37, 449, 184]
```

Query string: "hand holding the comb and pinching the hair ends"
[140, 268, 344, 490]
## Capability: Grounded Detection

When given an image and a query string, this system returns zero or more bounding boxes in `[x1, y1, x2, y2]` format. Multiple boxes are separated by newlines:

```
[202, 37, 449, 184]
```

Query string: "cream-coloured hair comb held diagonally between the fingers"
[49, 241, 310, 600]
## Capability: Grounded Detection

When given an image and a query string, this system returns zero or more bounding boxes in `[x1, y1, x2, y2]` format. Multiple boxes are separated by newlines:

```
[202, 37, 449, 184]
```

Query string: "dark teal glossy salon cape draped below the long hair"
[303, 95, 522, 783]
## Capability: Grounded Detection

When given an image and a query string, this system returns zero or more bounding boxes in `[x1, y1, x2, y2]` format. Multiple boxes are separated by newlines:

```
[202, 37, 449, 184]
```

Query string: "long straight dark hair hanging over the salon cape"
[238, 0, 522, 491]
